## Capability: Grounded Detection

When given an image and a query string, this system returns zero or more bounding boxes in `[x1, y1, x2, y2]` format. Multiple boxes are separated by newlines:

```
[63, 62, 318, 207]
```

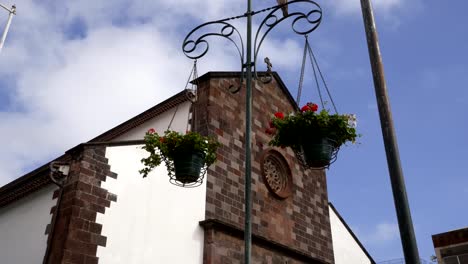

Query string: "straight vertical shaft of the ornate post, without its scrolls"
[244, 0, 252, 264]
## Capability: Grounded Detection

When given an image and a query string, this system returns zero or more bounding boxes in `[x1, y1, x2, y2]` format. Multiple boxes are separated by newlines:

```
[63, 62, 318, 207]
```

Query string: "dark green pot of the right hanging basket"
[302, 138, 335, 168]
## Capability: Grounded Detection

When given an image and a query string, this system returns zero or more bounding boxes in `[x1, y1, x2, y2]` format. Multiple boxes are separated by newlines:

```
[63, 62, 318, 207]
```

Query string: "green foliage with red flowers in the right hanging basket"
[269, 106, 359, 149]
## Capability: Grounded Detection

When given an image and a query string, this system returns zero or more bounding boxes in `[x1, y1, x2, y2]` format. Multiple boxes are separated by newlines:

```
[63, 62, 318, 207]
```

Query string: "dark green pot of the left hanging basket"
[174, 152, 205, 184]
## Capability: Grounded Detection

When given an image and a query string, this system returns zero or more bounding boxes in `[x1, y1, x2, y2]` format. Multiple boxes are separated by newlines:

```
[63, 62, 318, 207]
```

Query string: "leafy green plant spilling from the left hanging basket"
[139, 129, 220, 177]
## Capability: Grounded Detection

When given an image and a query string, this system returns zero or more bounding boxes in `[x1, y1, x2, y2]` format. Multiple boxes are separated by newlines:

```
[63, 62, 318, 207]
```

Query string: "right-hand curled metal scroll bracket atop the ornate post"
[254, 0, 322, 83]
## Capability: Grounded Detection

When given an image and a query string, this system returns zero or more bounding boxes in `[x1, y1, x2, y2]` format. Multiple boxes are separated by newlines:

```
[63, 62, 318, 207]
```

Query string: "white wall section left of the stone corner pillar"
[0, 184, 57, 264]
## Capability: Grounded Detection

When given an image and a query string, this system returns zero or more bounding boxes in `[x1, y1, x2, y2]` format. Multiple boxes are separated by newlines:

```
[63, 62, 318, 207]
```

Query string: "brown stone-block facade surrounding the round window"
[193, 73, 334, 264]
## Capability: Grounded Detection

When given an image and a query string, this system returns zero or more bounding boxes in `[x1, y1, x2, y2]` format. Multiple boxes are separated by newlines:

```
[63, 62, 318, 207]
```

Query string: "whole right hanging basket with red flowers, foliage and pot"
[266, 103, 358, 169]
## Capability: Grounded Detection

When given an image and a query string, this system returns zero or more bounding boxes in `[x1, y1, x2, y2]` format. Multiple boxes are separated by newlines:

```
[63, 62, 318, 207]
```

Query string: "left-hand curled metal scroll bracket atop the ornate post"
[182, 18, 244, 93]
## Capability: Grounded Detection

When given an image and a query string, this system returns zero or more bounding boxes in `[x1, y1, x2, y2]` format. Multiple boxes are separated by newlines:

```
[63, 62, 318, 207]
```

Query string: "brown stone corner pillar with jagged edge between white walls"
[45, 145, 117, 264]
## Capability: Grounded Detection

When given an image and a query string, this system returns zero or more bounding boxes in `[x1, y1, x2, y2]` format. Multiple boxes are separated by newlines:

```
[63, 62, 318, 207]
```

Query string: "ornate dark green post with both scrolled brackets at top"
[182, 0, 322, 264]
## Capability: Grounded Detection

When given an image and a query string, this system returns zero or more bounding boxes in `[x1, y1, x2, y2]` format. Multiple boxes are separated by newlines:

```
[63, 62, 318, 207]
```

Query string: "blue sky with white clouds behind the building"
[0, 0, 468, 261]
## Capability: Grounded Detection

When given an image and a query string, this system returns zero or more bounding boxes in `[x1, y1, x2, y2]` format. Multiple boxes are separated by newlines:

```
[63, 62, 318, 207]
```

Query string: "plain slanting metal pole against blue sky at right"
[361, 0, 420, 264]
